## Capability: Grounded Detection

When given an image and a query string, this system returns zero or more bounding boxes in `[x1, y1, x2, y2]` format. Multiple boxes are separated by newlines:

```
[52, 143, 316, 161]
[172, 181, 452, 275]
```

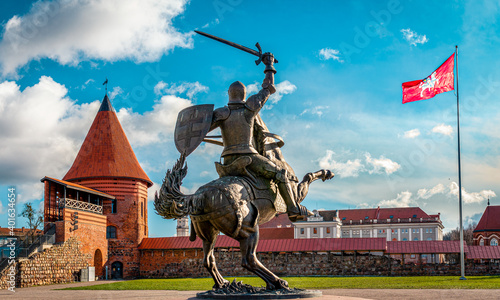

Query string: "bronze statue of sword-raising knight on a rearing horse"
[154, 34, 333, 290]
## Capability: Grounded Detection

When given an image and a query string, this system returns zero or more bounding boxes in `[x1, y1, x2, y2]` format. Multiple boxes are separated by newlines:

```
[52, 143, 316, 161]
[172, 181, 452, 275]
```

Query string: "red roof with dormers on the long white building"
[338, 207, 430, 221]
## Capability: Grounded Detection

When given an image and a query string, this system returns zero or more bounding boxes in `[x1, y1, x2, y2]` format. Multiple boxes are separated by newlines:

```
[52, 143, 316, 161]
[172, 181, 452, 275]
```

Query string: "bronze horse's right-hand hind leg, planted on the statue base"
[240, 231, 288, 290]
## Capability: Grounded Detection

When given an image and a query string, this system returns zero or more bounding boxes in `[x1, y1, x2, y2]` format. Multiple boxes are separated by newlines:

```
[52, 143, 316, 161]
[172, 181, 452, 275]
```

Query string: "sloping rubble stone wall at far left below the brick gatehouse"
[0, 238, 91, 289]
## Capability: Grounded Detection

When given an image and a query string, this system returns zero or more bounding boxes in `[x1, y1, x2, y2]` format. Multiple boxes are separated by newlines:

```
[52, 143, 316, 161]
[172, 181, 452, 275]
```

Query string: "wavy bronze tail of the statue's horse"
[154, 154, 191, 219]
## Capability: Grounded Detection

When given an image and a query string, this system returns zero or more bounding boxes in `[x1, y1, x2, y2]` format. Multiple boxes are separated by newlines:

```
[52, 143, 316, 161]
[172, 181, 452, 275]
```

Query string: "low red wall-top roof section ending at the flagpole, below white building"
[387, 241, 467, 254]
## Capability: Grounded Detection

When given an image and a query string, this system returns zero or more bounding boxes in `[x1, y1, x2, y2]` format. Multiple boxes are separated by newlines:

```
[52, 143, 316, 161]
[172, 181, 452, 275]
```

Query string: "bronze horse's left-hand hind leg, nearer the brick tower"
[197, 222, 229, 289]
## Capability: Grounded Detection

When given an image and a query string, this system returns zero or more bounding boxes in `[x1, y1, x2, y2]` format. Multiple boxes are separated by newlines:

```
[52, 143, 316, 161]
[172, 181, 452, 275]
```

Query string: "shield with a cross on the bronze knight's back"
[174, 104, 214, 156]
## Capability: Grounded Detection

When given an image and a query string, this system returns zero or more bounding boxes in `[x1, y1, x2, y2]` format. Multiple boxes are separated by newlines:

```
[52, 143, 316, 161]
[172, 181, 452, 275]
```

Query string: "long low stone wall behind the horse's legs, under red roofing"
[140, 249, 500, 278]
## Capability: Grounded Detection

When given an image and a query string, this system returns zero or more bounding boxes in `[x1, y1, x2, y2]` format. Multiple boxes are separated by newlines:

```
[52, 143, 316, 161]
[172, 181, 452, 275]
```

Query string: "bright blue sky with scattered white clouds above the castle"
[0, 0, 500, 236]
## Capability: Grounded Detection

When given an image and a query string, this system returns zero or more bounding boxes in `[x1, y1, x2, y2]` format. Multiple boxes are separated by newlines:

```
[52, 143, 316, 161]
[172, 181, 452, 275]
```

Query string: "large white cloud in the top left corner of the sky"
[0, 0, 193, 75]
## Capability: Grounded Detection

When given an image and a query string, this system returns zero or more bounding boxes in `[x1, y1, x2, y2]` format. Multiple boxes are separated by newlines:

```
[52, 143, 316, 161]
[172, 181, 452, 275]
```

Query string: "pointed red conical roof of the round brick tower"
[63, 95, 153, 187]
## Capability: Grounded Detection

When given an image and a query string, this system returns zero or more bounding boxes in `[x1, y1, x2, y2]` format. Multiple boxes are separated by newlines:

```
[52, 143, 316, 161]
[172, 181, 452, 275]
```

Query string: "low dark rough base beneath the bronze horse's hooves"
[196, 280, 323, 300]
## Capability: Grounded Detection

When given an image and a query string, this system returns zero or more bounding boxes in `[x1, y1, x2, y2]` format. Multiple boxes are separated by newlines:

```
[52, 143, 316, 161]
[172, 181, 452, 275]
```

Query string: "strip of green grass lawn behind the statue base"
[62, 276, 500, 291]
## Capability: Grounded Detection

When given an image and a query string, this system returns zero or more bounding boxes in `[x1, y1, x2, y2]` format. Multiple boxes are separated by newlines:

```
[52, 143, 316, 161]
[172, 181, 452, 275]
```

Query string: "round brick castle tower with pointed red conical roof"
[63, 95, 153, 278]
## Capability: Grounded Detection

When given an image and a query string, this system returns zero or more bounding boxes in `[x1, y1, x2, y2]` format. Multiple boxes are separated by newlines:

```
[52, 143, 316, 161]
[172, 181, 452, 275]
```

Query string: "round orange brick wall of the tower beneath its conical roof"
[73, 178, 148, 278]
